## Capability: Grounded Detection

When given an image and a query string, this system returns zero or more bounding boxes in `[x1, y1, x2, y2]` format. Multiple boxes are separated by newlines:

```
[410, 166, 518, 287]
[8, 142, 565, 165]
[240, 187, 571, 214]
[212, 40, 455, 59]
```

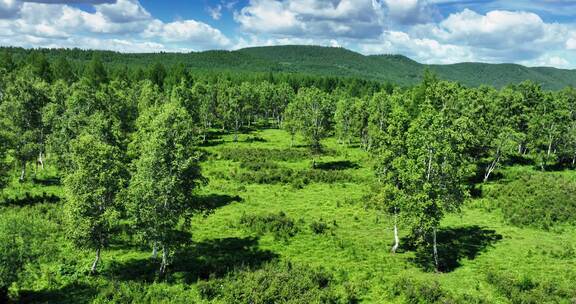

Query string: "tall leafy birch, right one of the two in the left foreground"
[128, 102, 205, 276]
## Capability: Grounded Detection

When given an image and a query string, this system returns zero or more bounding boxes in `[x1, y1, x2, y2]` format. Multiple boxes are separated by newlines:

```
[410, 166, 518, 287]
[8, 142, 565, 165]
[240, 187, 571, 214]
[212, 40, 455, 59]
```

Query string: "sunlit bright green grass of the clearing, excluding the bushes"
[0, 129, 576, 303]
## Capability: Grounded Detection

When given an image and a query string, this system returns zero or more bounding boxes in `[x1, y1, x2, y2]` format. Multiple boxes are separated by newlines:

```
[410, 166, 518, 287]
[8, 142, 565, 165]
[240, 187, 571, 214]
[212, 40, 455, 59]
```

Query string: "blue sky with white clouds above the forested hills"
[0, 0, 576, 69]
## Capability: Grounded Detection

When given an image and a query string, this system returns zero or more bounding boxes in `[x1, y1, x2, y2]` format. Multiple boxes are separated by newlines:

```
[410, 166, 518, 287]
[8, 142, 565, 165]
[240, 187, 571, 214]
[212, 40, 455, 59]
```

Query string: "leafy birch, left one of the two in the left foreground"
[64, 135, 126, 271]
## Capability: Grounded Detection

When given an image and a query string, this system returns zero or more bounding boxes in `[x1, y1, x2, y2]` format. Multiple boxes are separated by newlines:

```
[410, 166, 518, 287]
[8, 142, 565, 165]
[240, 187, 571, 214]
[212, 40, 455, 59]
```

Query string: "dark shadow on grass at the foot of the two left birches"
[111, 237, 278, 283]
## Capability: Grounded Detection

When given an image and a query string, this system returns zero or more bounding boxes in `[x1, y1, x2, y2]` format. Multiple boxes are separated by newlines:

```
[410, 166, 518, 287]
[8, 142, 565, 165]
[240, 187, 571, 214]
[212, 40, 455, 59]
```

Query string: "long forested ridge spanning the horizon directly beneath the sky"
[3, 45, 576, 89]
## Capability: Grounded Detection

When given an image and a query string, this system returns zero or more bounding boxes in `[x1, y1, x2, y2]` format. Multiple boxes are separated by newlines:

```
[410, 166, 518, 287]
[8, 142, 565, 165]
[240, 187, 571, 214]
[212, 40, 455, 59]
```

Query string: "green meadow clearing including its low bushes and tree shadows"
[0, 129, 576, 303]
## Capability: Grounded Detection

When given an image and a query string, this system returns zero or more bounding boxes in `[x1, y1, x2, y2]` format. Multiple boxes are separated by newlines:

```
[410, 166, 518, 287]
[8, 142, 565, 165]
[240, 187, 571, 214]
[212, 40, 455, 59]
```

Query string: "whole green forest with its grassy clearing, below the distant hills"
[0, 48, 576, 304]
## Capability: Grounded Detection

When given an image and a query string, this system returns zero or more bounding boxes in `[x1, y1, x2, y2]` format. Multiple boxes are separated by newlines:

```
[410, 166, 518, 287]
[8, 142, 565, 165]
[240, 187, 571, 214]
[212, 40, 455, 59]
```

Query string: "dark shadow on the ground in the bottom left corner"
[17, 284, 97, 304]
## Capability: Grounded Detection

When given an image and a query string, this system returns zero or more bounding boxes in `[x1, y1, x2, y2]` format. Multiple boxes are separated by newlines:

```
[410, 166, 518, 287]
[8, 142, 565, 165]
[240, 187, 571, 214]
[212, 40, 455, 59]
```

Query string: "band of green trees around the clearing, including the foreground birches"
[0, 53, 576, 288]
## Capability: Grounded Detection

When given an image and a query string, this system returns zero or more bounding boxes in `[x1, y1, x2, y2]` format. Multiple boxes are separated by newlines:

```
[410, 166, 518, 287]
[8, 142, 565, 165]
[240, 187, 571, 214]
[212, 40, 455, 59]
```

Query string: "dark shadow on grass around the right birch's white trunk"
[402, 226, 502, 272]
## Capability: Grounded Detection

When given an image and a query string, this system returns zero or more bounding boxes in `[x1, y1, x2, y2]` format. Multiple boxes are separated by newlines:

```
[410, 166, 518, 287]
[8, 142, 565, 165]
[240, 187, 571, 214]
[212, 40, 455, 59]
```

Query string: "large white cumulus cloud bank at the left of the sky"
[0, 0, 230, 52]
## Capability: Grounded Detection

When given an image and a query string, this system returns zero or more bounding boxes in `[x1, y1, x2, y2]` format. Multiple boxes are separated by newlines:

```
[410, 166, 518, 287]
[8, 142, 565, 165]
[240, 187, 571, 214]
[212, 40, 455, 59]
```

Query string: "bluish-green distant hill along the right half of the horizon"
[236, 46, 576, 89]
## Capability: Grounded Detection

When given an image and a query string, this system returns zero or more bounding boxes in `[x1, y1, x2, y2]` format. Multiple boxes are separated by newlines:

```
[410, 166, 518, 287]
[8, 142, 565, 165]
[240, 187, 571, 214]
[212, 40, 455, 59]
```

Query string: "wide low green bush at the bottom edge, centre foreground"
[197, 263, 357, 304]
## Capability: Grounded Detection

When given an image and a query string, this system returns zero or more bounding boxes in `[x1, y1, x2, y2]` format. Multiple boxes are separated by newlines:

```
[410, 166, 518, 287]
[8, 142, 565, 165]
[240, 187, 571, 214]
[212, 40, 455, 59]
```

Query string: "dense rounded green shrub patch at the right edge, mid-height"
[491, 173, 576, 229]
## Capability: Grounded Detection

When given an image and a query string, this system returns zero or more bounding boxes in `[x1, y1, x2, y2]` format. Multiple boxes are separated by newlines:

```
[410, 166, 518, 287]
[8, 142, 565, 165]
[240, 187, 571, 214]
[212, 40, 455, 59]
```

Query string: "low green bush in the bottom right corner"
[486, 271, 576, 304]
